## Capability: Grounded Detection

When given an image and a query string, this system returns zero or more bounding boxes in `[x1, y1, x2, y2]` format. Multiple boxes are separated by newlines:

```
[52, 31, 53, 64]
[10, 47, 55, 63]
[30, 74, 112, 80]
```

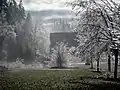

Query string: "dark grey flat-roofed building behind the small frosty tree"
[50, 32, 78, 48]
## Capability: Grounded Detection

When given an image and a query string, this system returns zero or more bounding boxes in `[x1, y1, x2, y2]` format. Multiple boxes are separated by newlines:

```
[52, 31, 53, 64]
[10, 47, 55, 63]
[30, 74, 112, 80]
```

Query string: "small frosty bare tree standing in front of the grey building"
[50, 42, 69, 68]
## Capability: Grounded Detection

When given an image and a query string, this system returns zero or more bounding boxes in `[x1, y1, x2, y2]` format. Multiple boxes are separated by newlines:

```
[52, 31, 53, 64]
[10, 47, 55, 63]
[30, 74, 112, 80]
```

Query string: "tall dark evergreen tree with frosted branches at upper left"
[0, 0, 25, 60]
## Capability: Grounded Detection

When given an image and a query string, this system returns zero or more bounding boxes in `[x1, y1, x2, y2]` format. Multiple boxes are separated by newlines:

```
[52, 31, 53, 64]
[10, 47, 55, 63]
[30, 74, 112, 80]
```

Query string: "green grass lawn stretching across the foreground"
[0, 70, 120, 90]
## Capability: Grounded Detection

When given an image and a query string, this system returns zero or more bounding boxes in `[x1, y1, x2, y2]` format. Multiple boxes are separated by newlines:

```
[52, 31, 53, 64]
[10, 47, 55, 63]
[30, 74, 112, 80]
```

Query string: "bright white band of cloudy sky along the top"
[18, 0, 72, 11]
